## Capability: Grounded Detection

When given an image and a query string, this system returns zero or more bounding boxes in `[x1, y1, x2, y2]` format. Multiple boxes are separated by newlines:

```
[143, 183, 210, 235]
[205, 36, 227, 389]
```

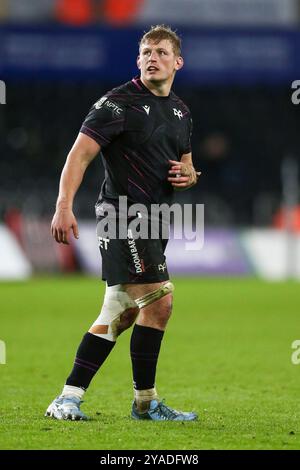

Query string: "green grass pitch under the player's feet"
[0, 276, 300, 450]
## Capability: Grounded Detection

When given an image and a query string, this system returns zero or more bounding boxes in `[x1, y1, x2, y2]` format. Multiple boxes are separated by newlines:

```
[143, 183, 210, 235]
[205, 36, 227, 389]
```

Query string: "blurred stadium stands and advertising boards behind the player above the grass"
[0, 0, 300, 279]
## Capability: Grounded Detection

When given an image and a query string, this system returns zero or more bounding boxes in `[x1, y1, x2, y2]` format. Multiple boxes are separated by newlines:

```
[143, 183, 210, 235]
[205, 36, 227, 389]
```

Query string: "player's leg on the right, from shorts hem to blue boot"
[124, 282, 197, 421]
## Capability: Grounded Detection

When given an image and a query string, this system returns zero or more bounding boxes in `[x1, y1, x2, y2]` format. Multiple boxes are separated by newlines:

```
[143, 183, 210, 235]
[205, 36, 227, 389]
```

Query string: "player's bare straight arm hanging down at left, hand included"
[51, 133, 100, 245]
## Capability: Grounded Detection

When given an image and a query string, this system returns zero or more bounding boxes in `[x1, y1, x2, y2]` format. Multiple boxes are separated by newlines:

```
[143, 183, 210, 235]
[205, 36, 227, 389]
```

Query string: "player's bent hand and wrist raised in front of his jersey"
[168, 152, 201, 191]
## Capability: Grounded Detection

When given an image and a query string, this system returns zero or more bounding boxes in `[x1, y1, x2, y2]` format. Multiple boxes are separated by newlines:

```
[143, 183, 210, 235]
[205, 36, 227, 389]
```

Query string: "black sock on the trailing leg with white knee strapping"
[66, 333, 116, 389]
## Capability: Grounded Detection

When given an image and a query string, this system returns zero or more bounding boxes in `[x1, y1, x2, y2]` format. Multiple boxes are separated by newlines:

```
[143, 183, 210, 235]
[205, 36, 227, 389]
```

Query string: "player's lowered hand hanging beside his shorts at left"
[51, 208, 79, 245]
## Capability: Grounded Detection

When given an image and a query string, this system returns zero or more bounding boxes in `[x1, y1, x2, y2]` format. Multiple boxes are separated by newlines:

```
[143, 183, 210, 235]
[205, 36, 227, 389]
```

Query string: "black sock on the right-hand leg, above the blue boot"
[130, 325, 164, 390]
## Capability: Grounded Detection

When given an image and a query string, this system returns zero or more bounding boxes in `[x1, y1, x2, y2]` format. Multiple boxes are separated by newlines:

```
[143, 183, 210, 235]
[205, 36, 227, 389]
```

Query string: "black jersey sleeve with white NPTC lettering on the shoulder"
[80, 96, 125, 149]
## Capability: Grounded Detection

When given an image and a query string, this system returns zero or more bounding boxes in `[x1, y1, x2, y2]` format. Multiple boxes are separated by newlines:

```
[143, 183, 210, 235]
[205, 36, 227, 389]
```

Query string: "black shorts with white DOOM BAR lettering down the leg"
[97, 217, 169, 286]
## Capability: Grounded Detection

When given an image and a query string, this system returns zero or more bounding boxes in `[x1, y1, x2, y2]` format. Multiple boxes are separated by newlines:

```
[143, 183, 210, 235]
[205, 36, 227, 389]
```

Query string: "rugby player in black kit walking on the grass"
[45, 25, 200, 421]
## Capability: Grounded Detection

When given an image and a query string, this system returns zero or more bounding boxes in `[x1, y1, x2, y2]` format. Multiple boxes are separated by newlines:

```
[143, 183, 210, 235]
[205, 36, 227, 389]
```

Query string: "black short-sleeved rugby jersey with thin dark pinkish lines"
[80, 77, 192, 211]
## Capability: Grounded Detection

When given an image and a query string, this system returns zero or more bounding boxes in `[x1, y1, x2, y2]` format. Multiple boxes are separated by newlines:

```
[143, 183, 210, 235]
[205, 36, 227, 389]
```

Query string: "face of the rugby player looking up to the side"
[137, 39, 183, 83]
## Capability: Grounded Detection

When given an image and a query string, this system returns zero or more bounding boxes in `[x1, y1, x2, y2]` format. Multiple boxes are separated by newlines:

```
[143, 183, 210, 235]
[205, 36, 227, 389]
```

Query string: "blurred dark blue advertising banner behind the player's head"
[0, 26, 300, 85]
